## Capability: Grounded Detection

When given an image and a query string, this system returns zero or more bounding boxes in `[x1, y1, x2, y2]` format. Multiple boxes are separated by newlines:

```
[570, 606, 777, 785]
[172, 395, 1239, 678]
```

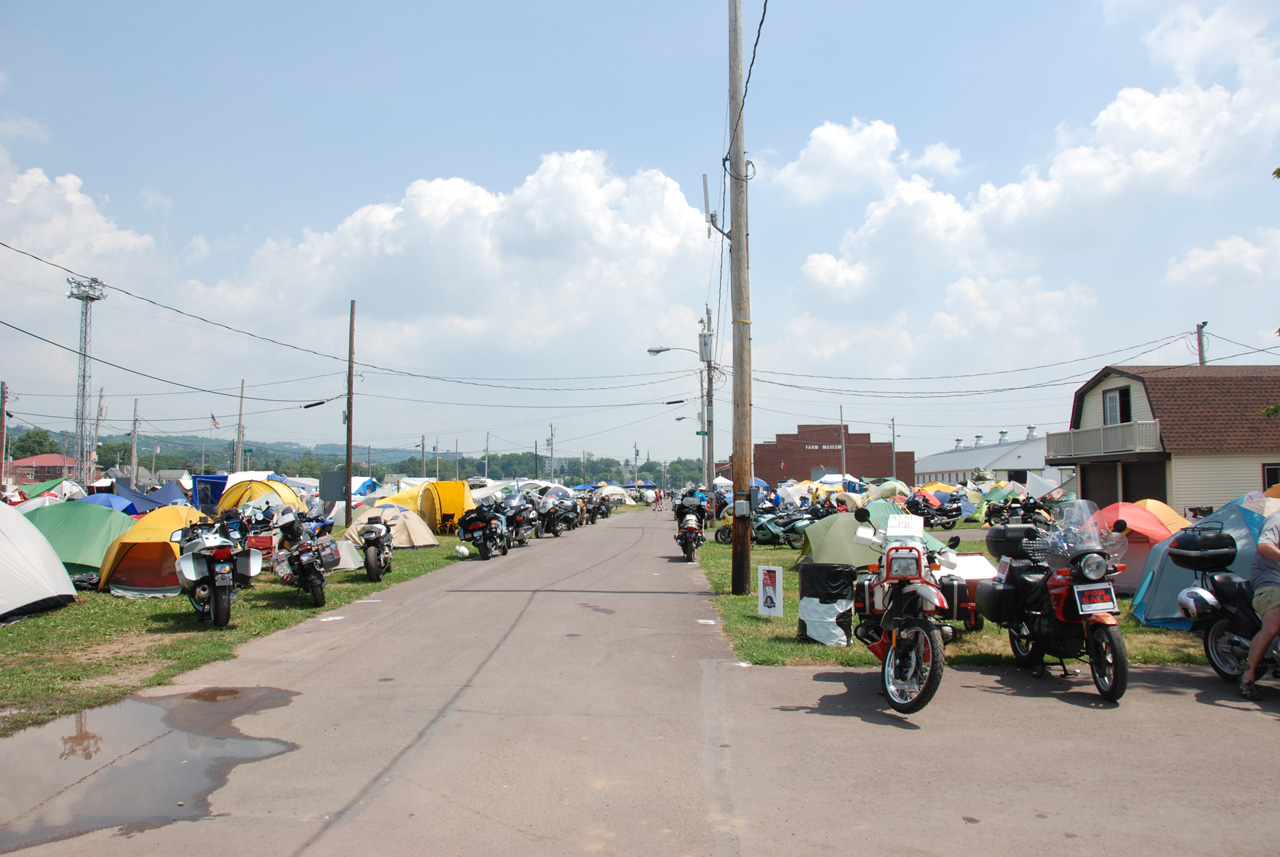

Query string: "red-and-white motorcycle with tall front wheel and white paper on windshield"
[854, 508, 968, 714]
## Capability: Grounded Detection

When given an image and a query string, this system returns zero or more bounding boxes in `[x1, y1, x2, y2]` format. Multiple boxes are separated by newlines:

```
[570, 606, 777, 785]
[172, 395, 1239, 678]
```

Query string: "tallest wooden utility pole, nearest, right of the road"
[732, 0, 751, 595]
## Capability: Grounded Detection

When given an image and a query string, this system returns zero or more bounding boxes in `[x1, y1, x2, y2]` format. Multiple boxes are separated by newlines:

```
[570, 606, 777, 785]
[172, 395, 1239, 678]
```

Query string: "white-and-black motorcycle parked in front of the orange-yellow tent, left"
[169, 522, 262, 628]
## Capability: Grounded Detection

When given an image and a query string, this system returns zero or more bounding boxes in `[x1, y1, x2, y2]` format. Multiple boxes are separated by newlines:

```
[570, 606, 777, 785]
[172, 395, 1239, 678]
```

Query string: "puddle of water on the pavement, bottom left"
[0, 688, 296, 852]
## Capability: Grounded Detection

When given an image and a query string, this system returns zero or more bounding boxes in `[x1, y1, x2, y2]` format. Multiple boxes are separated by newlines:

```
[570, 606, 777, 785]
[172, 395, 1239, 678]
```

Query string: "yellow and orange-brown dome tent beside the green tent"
[97, 505, 209, 595]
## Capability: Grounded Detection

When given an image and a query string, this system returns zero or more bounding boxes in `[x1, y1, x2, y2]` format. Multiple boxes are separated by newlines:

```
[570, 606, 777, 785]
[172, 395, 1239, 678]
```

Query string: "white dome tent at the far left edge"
[0, 503, 76, 623]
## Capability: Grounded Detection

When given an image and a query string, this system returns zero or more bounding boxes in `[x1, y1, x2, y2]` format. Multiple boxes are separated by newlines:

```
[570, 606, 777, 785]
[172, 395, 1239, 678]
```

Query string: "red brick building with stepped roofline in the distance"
[754, 423, 915, 485]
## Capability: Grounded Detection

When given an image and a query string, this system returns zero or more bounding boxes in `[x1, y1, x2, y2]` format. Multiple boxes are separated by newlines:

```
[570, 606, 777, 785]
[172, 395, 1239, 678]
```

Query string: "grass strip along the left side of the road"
[0, 536, 471, 737]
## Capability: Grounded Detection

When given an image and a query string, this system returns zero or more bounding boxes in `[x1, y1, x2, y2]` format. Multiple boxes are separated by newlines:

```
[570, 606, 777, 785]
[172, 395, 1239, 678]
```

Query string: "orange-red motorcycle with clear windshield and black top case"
[977, 500, 1129, 702]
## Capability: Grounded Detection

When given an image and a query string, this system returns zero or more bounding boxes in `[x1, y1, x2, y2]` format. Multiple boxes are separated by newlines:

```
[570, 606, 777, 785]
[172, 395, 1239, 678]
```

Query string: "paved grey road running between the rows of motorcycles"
[6, 512, 1280, 857]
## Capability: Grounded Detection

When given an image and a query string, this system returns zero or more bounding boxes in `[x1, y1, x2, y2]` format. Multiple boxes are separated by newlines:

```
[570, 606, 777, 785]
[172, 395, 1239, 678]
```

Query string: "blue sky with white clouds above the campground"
[0, 0, 1280, 477]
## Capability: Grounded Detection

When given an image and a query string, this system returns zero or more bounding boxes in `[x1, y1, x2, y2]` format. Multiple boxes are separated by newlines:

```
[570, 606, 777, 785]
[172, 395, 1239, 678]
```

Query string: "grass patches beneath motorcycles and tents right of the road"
[699, 544, 1206, 666]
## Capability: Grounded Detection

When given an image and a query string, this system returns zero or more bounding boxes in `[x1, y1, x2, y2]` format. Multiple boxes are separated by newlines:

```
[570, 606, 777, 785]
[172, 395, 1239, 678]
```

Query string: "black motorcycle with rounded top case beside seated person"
[1169, 522, 1280, 684]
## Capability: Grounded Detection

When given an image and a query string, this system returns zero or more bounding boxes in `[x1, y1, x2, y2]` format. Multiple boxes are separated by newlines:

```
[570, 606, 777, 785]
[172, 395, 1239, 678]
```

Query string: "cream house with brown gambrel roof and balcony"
[1044, 366, 1280, 513]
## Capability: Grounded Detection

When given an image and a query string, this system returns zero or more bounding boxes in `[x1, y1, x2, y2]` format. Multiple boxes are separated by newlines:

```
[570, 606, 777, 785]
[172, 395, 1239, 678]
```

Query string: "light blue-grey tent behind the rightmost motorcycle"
[1133, 503, 1265, 629]
